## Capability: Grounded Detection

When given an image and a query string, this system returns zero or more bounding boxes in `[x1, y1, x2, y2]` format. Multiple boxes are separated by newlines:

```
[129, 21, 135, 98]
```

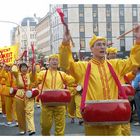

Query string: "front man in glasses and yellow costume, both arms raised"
[59, 26, 140, 136]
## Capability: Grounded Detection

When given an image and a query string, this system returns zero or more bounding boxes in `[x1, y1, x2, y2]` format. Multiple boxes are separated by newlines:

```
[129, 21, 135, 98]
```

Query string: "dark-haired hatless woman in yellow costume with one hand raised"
[12, 63, 35, 135]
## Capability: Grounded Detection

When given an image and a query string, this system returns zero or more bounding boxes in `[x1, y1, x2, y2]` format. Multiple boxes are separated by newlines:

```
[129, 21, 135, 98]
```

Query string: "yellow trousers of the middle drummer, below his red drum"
[41, 105, 66, 136]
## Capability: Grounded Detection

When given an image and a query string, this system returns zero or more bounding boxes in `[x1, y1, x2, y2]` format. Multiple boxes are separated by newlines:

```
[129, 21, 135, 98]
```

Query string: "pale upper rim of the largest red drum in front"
[86, 99, 128, 104]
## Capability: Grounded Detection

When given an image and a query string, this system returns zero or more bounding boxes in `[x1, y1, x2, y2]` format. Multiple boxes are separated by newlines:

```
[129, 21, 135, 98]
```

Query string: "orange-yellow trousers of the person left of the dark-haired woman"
[5, 96, 17, 122]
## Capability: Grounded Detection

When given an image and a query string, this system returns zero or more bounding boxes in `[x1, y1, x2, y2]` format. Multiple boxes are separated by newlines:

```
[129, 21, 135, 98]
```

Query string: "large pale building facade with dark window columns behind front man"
[50, 4, 140, 57]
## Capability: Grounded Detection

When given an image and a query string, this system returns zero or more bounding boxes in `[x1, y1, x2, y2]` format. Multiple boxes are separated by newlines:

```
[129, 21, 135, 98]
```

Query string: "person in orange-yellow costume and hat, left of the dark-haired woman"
[2, 63, 17, 126]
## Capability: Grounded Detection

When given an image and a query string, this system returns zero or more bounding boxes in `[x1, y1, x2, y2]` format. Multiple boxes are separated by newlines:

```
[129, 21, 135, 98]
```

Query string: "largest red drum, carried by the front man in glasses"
[82, 100, 131, 125]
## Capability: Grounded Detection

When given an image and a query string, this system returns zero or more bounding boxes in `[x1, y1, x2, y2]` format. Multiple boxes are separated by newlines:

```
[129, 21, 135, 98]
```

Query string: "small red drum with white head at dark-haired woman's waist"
[25, 88, 39, 98]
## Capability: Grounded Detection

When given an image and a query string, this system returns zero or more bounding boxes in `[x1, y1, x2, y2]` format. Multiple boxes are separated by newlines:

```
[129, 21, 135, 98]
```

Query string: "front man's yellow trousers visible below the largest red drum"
[85, 124, 122, 136]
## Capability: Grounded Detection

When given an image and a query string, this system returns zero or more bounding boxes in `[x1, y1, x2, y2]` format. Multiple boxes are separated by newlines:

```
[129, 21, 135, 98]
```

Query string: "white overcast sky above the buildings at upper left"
[0, 0, 49, 46]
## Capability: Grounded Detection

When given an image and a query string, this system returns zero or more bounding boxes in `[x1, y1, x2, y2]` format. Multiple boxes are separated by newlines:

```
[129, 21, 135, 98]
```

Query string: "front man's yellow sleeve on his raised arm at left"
[59, 43, 88, 83]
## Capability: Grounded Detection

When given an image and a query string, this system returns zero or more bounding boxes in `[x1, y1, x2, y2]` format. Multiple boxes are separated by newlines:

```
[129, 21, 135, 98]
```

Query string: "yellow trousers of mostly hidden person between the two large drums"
[68, 94, 82, 119]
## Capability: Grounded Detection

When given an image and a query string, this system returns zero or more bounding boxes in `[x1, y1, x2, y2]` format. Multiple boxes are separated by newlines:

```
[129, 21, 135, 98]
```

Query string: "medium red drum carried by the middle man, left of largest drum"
[40, 89, 71, 106]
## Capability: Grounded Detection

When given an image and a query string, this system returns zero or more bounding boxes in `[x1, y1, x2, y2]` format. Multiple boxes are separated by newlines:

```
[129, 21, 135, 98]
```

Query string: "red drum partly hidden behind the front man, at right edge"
[122, 84, 135, 96]
